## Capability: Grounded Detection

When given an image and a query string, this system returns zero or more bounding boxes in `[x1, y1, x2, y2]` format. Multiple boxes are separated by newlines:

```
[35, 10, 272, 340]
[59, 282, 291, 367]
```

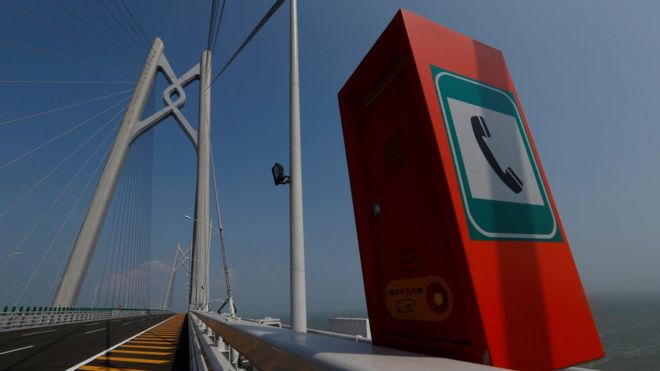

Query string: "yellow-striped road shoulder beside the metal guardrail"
[79, 314, 188, 371]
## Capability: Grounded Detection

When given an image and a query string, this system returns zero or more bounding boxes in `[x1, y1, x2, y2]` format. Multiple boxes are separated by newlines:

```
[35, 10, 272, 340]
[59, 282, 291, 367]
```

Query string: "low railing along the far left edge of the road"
[0, 307, 167, 332]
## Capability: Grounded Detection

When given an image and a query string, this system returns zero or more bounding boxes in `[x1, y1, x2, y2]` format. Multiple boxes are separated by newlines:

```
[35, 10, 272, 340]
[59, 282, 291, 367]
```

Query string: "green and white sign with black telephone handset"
[431, 66, 561, 241]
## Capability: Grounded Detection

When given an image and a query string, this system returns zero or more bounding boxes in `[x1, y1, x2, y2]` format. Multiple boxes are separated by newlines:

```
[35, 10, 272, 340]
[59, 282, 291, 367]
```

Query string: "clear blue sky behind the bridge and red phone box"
[0, 0, 660, 316]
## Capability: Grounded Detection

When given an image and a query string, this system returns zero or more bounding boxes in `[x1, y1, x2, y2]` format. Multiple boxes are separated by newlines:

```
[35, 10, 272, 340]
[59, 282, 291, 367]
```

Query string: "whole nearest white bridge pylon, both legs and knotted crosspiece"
[53, 38, 211, 309]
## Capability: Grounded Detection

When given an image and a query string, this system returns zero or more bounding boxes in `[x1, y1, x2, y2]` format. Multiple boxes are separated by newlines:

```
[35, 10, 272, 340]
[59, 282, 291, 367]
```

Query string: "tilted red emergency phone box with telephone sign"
[339, 11, 603, 370]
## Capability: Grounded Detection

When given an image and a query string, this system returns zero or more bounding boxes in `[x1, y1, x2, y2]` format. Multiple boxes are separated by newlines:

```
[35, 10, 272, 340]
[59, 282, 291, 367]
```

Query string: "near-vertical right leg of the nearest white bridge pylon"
[189, 50, 211, 310]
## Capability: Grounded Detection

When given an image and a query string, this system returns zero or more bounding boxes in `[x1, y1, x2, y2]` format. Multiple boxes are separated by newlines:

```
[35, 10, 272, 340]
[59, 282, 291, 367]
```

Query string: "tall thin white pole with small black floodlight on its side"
[289, 0, 307, 332]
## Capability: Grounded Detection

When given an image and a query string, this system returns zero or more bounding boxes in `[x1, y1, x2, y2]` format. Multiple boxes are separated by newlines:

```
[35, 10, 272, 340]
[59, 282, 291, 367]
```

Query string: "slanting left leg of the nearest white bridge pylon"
[53, 38, 164, 307]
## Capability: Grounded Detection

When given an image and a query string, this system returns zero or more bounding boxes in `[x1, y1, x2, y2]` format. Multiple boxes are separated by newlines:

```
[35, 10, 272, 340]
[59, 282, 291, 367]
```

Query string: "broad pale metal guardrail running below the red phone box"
[193, 311, 497, 371]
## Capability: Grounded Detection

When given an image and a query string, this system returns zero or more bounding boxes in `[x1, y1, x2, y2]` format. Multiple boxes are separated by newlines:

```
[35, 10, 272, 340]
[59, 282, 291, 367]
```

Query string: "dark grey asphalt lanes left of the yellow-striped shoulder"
[0, 314, 173, 370]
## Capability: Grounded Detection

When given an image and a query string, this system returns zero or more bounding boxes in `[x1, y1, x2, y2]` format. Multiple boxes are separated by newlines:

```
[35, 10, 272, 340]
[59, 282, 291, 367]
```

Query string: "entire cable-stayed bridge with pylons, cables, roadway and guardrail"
[0, 0, 500, 370]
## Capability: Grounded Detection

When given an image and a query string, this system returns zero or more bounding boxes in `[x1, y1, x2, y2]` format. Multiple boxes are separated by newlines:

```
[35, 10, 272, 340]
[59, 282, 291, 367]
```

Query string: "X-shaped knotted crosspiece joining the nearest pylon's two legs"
[130, 54, 200, 148]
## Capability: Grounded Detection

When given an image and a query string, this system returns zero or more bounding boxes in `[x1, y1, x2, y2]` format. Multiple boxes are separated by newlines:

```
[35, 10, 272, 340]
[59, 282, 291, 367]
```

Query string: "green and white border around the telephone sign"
[431, 65, 562, 242]
